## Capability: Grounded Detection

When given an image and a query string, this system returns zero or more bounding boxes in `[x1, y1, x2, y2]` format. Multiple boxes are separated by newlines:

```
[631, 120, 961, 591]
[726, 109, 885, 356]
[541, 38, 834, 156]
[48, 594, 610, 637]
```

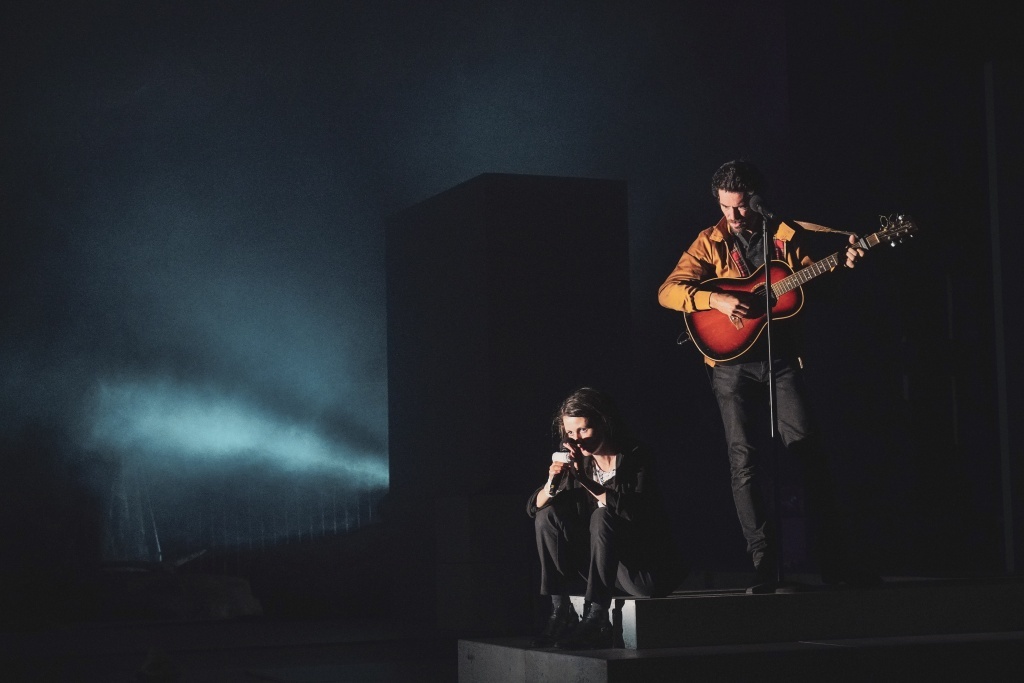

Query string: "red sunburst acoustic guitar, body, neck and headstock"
[683, 215, 918, 361]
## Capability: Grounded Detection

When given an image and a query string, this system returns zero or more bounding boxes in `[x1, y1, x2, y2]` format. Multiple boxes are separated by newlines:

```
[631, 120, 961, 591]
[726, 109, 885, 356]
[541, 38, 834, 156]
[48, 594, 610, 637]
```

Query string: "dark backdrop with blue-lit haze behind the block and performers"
[0, 0, 1020, 630]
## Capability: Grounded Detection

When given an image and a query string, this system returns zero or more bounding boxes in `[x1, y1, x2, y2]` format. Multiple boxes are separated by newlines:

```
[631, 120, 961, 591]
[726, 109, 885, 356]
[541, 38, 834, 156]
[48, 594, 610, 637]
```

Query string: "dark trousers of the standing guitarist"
[712, 359, 842, 572]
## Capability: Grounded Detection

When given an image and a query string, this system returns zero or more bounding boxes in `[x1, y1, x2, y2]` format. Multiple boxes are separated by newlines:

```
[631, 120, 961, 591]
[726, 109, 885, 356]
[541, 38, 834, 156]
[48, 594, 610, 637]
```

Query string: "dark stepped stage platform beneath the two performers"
[459, 579, 1024, 683]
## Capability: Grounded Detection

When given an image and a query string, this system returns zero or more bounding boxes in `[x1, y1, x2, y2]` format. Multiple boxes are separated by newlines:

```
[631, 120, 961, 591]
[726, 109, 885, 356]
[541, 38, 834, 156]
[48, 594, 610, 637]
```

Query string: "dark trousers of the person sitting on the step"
[534, 495, 684, 605]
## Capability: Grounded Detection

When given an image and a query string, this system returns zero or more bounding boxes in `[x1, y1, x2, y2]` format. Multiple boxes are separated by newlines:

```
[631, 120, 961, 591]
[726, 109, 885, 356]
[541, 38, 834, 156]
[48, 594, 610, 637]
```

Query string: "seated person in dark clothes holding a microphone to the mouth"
[526, 387, 687, 649]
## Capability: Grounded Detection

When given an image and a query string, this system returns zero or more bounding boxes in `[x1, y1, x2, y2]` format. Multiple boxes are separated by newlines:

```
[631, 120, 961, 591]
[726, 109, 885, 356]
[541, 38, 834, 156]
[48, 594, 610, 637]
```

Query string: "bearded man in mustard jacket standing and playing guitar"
[657, 161, 878, 593]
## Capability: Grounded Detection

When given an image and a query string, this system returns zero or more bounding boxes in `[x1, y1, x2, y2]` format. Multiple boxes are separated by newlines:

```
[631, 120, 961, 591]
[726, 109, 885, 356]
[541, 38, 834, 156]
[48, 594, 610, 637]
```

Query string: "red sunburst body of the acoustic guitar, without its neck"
[683, 261, 804, 361]
